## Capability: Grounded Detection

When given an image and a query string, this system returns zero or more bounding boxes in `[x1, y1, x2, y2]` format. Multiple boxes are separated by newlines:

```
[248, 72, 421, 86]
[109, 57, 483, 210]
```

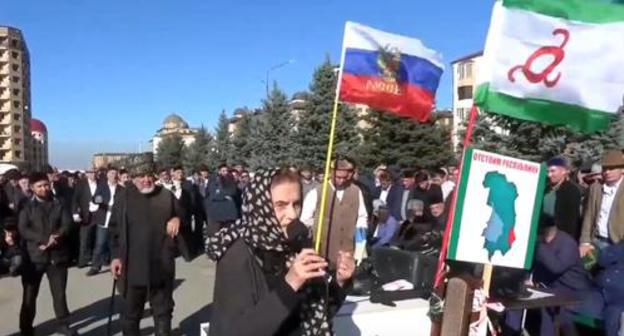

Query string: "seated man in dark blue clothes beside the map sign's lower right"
[506, 216, 604, 335]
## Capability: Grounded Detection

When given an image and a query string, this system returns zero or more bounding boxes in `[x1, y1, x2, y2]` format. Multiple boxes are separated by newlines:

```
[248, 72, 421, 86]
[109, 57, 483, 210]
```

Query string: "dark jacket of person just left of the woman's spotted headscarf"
[204, 176, 240, 222]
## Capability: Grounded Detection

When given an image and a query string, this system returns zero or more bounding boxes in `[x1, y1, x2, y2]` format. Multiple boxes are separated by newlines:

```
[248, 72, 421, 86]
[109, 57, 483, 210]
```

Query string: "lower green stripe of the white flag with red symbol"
[475, 84, 615, 133]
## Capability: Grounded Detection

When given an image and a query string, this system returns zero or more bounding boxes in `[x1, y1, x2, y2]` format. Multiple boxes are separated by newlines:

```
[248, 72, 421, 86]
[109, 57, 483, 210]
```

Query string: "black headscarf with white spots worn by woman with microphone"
[206, 169, 333, 336]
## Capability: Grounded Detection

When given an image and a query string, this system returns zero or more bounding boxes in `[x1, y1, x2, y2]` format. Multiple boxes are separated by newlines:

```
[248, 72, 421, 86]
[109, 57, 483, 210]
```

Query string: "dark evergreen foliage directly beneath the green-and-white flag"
[462, 113, 624, 166]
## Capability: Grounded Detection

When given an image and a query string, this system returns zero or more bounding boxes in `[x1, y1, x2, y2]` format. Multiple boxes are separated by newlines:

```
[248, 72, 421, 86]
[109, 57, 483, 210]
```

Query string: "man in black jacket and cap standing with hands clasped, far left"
[18, 173, 75, 335]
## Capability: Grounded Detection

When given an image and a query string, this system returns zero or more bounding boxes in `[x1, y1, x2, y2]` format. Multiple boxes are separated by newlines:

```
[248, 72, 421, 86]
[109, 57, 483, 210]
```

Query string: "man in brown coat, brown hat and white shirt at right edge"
[570, 150, 624, 256]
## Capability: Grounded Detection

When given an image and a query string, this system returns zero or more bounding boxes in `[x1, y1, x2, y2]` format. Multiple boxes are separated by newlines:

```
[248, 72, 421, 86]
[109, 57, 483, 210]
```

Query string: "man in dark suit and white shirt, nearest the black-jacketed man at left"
[71, 169, 100, 268]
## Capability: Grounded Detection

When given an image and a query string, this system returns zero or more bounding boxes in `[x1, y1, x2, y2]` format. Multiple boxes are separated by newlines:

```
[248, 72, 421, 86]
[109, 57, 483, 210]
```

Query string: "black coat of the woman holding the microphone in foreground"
[209, 239, 345, 336]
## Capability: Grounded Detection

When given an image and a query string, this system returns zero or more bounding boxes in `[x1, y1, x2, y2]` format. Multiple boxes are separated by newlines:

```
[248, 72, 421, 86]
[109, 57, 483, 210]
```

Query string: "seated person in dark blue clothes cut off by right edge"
[596, 242, 624, 336]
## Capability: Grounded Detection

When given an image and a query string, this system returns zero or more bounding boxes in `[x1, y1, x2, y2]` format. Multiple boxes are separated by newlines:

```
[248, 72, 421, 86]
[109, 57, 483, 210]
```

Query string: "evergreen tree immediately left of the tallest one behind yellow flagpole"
[247, 84, 291, 169]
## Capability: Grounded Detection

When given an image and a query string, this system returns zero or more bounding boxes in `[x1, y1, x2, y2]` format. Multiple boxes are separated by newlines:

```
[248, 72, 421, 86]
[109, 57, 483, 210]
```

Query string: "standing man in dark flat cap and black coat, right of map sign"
[543, 155, 582, 241]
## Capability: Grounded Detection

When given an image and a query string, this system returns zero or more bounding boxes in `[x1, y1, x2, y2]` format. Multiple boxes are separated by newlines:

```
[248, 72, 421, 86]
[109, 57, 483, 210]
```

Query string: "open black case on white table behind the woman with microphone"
[371, 247, 438, 289]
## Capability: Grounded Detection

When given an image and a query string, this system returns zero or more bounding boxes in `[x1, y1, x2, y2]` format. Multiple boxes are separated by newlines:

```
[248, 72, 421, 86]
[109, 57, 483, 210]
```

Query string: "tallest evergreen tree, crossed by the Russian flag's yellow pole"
[291, 57, 360, 169]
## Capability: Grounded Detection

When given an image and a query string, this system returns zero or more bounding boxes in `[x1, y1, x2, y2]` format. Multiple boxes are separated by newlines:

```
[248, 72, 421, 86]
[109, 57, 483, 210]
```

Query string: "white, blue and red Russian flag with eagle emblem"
[340, 22, 444, 122]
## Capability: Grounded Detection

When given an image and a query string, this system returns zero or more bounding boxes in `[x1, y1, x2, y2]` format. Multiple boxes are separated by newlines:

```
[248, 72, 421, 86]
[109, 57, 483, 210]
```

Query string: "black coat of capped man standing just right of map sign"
[555, 180, 582, 241]
